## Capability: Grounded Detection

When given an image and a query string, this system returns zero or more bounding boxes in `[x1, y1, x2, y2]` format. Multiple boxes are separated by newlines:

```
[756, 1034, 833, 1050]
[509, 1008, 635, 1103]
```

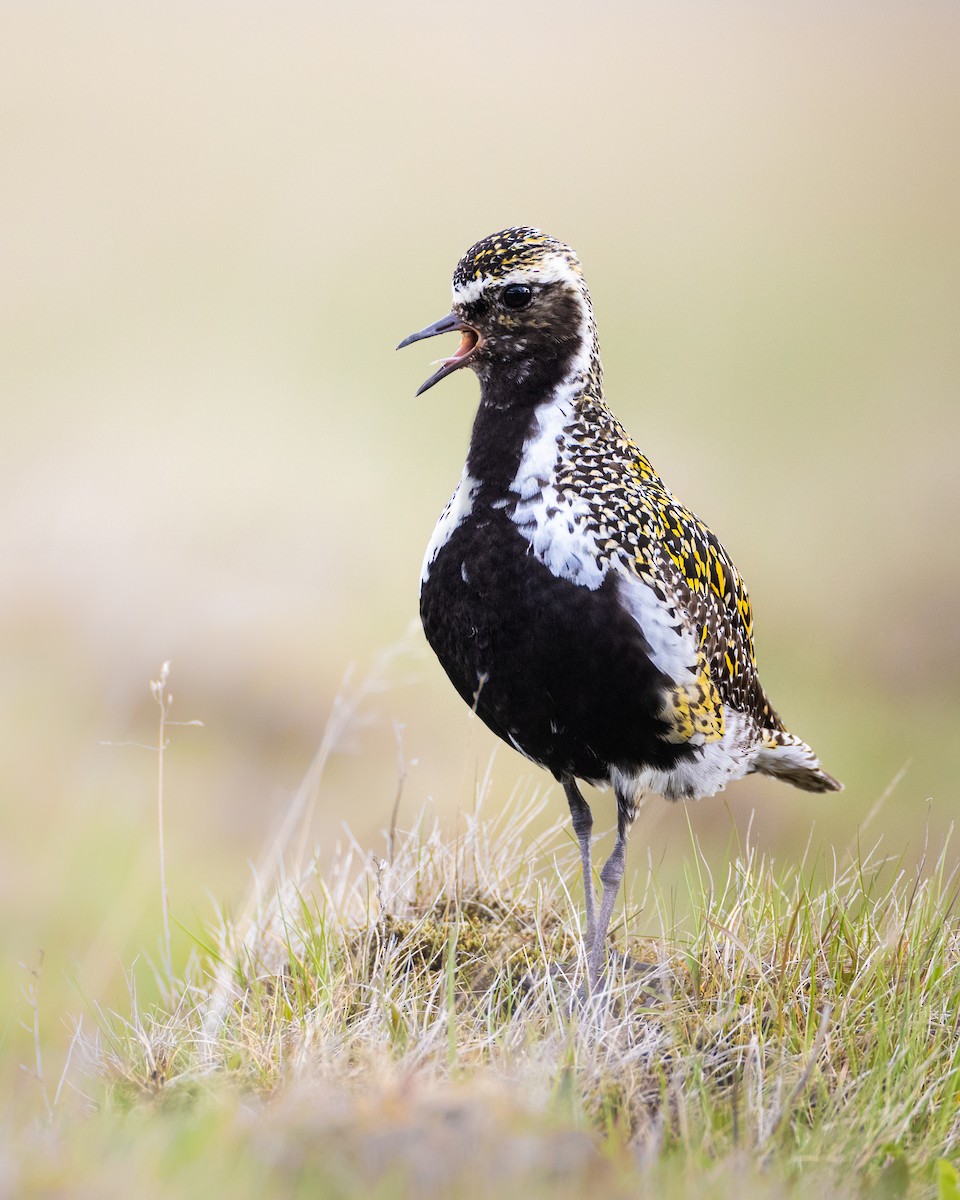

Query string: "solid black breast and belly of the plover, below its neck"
[420, 497, 690, 781]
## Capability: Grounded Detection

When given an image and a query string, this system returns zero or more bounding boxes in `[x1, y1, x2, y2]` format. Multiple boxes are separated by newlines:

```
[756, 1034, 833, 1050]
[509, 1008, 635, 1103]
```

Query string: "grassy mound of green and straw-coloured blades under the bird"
[7, 763, 960, 1200]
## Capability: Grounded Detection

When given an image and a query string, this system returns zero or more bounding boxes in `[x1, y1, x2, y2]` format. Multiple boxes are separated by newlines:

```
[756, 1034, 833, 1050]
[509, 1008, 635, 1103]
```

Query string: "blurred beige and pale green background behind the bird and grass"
[0, 0, 960, 1085]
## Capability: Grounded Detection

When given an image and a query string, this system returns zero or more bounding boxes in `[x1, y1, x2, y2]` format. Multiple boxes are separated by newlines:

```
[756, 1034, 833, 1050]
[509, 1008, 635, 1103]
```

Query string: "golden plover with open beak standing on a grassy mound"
[397, 226, 842, 990]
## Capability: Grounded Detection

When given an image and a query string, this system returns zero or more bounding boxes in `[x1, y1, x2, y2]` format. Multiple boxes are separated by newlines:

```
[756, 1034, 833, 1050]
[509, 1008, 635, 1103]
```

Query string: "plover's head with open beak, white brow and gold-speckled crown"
[397, 226, 599, 405]
